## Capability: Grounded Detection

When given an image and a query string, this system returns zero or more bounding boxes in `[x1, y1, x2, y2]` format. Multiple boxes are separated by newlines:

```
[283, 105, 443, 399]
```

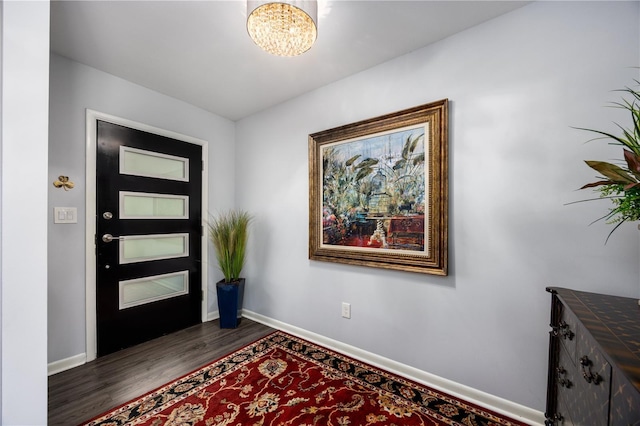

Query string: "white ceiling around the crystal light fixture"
[51, 0, 528, 121]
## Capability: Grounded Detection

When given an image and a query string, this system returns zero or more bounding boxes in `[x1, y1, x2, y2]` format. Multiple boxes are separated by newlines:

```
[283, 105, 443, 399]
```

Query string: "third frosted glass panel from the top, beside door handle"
[120, 234, 189, 265]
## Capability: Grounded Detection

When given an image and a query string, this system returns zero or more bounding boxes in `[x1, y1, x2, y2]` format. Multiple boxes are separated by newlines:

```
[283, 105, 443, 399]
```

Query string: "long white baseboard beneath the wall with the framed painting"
[242, 309, 545, 426]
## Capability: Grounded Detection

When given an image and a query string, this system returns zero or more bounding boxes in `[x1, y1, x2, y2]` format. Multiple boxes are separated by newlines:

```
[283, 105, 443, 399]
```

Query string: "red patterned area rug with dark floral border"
[85, 331, 524, 426]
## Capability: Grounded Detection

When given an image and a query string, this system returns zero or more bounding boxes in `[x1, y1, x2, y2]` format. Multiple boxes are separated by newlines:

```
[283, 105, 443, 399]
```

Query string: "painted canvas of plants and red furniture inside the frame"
[320, 122, 429, 253]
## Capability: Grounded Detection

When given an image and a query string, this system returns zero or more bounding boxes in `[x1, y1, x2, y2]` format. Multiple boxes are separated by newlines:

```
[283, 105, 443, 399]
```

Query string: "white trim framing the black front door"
[85, 108, 209, 362]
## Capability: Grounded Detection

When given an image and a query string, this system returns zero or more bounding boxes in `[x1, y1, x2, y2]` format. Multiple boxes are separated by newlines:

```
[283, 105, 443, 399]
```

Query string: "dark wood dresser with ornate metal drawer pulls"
[545, 287, 640, 426]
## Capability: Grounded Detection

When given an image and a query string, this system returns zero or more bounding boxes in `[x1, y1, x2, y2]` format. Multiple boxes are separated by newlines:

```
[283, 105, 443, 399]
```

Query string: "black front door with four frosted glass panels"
[96, 120, 202, 356]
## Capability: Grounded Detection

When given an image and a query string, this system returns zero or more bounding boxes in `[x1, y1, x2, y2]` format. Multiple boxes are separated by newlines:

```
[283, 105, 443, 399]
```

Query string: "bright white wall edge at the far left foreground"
[0, 1, 49, 425]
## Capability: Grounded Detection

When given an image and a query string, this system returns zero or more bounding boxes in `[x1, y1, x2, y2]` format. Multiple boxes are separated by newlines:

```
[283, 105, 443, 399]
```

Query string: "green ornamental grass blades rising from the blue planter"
[208, 210, 252, 283]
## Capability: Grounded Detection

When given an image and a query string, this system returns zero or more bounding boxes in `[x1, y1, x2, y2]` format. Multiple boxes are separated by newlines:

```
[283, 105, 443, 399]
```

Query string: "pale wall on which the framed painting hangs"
[236, 2, 640, 411]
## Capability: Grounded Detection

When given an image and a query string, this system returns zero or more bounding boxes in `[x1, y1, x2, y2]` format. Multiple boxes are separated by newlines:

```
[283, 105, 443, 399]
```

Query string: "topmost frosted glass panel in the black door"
[120, 146, 189, 182]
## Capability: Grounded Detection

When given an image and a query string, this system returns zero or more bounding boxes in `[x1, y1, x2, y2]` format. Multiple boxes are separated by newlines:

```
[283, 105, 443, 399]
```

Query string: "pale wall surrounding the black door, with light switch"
[48, 55, 235, 362]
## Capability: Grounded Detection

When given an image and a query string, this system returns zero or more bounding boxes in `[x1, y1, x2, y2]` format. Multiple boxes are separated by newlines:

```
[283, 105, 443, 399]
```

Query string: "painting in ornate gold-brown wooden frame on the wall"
[309, 99, 448, 275]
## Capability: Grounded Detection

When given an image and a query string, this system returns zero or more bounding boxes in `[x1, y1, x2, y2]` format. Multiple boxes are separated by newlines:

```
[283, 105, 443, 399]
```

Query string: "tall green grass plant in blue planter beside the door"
[208, 210, 251, 328]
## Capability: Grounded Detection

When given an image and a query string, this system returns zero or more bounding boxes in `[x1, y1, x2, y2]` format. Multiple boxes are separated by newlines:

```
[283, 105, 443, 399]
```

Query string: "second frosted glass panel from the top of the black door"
[120, 191, 189, 219]
